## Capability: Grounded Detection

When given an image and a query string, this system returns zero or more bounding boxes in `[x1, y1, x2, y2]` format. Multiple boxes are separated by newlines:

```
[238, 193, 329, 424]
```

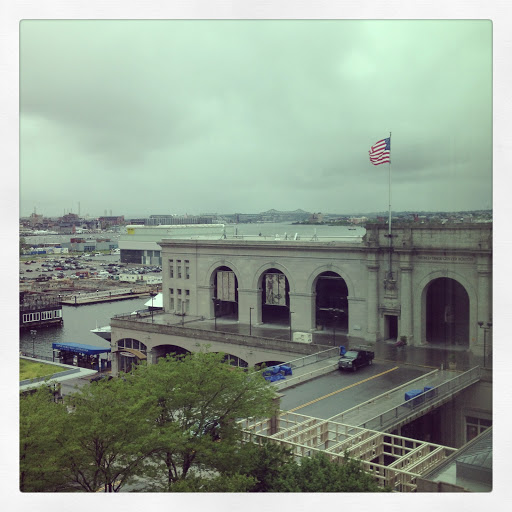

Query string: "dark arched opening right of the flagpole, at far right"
[426, 277, 469, 346]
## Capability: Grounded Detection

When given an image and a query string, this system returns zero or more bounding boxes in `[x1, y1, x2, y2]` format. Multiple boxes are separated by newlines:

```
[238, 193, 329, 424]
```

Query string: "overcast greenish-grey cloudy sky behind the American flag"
[20, 20, 492, 217]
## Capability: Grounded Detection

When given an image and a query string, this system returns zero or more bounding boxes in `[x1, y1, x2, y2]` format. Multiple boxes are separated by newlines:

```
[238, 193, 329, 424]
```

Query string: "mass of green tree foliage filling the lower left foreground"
[20, 353, 275, 492]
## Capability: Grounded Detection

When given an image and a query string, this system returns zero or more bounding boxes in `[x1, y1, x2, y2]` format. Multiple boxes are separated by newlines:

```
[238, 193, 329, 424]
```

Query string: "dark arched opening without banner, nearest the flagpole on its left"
[315, 271, 348, 332]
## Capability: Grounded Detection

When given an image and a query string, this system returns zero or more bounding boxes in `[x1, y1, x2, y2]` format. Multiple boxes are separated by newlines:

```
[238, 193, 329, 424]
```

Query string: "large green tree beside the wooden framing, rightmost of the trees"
[130, 352, 275, 491]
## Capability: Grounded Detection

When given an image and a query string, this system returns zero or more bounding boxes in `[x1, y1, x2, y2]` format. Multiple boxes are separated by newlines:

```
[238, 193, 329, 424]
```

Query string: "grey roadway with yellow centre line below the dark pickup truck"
[281, 360, 433, 419]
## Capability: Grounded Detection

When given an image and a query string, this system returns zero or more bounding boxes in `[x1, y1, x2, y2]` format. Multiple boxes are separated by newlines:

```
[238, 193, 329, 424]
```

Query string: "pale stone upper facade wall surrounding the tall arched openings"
[156, 224, 492, 353]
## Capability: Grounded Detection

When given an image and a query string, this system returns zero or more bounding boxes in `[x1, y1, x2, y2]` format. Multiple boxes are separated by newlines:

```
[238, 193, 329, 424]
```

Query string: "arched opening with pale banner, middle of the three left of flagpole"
[261, 268, 290, 325]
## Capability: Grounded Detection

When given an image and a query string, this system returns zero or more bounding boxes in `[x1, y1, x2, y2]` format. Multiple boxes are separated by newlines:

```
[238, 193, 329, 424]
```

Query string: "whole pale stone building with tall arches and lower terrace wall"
[112, 223, 492, 376]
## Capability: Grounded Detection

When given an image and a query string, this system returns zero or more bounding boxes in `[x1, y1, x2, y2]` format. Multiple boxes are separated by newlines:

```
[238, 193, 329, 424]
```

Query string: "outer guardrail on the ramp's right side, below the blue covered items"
[358, 366, 480, 430]
